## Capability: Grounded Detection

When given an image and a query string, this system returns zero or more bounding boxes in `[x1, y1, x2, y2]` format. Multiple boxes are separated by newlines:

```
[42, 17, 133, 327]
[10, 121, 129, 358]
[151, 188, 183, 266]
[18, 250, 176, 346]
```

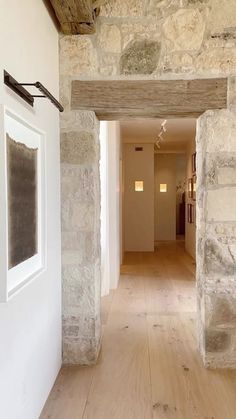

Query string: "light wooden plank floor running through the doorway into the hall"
[40, 242, 236, 419]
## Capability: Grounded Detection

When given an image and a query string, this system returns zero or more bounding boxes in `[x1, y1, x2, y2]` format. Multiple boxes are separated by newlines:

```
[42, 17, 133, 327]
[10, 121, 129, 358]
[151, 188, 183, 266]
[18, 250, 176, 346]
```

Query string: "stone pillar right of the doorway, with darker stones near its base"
[197, 108, 236, 368]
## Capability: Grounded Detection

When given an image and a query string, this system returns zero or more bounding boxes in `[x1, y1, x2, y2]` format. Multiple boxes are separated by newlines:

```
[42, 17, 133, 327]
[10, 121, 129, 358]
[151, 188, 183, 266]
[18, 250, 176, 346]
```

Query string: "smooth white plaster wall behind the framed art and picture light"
[0, 0, 61, 419]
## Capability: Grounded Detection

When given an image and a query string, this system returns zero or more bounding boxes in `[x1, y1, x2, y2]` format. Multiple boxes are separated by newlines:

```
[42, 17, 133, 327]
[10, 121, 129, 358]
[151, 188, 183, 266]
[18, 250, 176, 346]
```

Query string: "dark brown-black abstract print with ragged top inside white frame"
[6, 133, 38, 269]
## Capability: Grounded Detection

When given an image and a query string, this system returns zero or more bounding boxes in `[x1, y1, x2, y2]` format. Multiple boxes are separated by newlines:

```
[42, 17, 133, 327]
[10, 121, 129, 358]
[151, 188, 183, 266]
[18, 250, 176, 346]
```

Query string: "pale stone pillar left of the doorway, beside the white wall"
[61, 86, 101, 364]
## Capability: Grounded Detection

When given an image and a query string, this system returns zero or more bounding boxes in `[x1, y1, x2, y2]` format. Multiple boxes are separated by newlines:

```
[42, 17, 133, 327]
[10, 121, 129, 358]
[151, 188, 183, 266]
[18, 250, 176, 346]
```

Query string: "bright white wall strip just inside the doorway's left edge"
[100, 121, 121, 296]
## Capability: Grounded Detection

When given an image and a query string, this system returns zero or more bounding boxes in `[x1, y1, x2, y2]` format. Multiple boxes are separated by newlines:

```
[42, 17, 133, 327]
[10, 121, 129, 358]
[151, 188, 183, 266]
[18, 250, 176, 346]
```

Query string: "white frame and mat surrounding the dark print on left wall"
[0, 105, 46, 303]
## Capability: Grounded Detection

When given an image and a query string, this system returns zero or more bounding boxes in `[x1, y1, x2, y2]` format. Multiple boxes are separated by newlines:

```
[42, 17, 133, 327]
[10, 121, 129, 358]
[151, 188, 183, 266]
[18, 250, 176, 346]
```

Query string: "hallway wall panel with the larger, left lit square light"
[123, 144, 154, 252]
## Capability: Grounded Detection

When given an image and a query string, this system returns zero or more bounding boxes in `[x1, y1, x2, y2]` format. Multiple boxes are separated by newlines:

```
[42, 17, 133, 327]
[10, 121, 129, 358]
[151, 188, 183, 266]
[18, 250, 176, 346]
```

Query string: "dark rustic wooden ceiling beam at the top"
[50, 0, 101, 35]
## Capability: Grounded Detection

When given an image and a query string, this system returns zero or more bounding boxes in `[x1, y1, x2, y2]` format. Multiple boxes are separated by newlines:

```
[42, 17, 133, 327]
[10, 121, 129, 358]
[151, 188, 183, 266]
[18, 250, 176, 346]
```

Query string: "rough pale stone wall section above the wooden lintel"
[61, 0, 236, 78]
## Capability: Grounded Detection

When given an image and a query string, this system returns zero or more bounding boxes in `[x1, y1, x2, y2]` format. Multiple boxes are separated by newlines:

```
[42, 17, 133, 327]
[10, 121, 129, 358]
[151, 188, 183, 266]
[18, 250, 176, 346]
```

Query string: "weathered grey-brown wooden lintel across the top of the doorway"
[71, 78, 227, 120]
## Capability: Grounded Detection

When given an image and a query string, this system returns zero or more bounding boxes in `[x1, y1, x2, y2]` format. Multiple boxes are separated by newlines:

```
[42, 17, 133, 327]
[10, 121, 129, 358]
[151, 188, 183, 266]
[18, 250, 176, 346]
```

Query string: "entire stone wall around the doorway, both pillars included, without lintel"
[60, 0, 236, 368]
